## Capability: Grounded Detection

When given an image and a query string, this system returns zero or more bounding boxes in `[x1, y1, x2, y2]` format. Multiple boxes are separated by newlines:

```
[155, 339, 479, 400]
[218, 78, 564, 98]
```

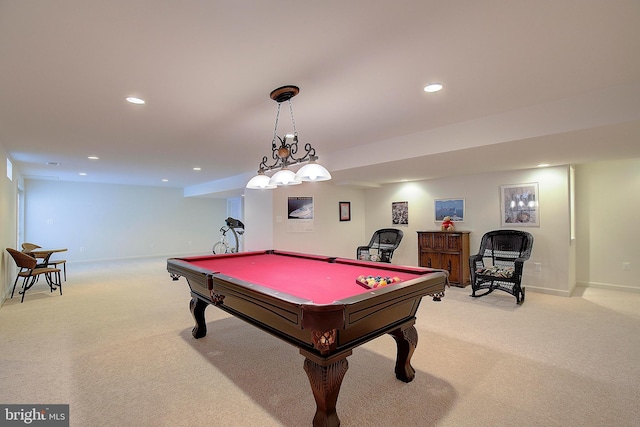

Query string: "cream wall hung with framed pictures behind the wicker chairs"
[262, 166, 575, 295]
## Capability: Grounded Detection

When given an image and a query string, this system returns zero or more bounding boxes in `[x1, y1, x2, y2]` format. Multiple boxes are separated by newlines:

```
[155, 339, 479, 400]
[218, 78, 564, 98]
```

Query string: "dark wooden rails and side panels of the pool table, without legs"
[167, 252, 447, 357]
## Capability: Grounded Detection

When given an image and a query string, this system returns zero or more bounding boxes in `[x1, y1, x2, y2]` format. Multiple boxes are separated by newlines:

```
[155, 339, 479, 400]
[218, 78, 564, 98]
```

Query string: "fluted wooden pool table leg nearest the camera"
[304, 357, 349, 427]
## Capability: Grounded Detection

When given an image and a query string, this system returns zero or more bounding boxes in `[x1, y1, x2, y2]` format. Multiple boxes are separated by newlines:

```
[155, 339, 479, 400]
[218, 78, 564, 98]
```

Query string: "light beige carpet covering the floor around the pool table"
[0, 258, 640, 427]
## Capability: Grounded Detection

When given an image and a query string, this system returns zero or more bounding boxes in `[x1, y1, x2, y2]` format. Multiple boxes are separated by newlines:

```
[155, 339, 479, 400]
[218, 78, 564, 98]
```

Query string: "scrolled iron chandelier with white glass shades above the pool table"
[247, 85, 331, 189]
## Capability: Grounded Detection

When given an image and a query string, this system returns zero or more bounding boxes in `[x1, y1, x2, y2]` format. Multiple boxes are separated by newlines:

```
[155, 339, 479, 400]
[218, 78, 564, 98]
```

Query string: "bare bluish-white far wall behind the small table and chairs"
[25, 180, 227, 262]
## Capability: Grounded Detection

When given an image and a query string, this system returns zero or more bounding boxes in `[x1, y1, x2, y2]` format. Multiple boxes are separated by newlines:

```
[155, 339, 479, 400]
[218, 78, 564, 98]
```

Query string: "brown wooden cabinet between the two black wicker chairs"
[418, 230, 470, 287]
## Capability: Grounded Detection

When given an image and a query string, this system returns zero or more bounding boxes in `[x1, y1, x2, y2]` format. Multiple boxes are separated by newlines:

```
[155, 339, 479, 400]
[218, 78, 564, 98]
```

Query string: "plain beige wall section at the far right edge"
[576, 159, 640, 291]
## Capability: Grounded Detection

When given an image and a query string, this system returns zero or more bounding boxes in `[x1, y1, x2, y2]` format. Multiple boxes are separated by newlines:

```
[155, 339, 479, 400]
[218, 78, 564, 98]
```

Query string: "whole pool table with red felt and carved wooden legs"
[167, 250, 448, 427]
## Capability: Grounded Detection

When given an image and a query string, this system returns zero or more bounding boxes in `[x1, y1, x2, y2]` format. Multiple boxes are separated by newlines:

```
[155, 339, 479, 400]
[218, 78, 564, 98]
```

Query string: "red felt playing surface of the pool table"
[182, 252, 424, 304]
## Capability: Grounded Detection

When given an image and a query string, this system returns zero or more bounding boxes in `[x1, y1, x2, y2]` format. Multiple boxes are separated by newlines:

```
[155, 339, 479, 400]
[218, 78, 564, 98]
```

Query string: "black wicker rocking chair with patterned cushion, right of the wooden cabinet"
[469, 230, 533, 304]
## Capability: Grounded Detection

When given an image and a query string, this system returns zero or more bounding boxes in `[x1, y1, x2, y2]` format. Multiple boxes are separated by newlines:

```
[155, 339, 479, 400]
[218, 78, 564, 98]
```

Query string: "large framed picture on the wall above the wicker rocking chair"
[500, 182, 540, 227]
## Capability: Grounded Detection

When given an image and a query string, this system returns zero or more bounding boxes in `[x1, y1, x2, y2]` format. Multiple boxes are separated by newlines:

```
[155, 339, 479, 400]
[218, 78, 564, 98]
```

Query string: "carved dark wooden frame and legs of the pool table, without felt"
[167, 250, 447, 427]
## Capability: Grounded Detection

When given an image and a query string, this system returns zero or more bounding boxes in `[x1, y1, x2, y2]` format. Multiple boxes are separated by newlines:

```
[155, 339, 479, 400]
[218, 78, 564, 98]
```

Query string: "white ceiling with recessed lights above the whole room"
[0, 0, 640, 195]
